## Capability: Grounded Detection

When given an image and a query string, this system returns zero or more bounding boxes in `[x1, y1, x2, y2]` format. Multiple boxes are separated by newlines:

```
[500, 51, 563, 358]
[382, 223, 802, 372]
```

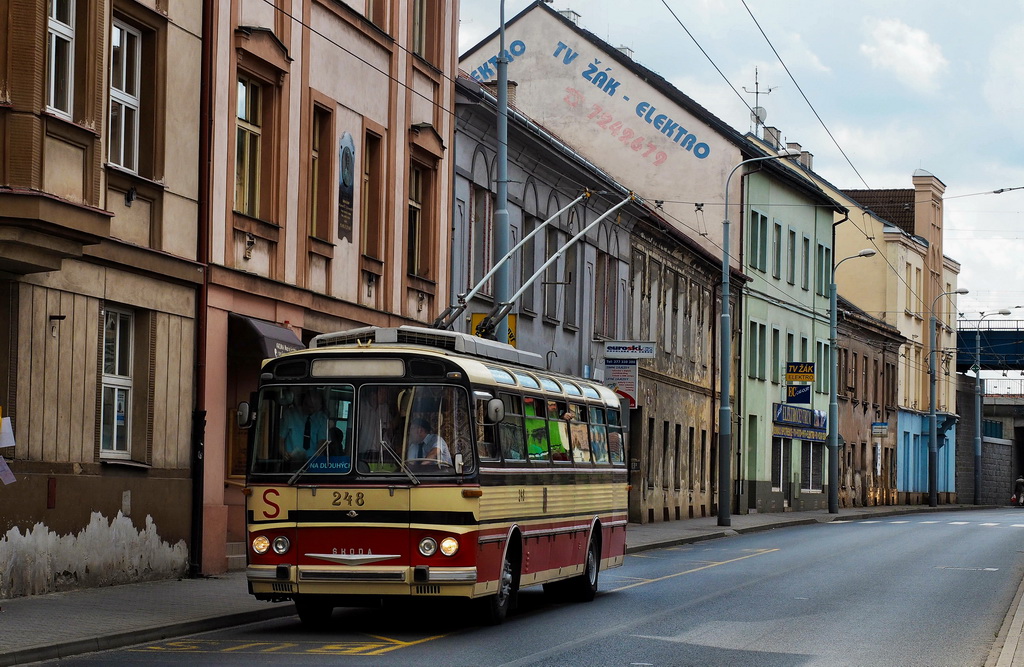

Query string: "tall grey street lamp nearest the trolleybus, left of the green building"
[718, 148, 800, 526]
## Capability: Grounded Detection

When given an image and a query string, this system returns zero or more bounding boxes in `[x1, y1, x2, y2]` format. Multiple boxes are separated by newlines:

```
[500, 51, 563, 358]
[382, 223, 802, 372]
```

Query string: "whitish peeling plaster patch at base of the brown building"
[0, 512, 188, 598]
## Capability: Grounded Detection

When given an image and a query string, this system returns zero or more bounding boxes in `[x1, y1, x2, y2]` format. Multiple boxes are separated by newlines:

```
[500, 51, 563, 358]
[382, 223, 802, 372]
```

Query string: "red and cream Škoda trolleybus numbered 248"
[239, 327, 627, 624]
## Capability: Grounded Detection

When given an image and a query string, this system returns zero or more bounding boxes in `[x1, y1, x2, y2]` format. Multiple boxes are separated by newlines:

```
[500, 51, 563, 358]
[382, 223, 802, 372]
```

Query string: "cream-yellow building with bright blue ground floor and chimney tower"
[764, 127, 959, 504]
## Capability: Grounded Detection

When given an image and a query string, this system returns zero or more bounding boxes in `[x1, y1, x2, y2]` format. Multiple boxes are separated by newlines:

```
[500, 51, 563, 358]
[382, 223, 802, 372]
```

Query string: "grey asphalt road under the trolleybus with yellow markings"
[49, 508, 1024, 666]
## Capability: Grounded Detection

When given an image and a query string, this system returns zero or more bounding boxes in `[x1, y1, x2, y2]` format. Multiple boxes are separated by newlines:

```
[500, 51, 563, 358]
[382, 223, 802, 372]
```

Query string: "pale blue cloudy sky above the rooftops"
[459, 0, 1024, 319]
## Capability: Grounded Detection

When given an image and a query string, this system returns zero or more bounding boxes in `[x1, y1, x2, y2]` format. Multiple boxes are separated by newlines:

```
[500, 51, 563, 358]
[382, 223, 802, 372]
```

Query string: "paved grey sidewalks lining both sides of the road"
[0, 505, 1024, 667]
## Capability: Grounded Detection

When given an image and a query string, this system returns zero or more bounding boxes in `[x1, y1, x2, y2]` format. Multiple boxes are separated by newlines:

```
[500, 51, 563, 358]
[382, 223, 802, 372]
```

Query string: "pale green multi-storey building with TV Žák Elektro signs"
[735, 158, 843, 512]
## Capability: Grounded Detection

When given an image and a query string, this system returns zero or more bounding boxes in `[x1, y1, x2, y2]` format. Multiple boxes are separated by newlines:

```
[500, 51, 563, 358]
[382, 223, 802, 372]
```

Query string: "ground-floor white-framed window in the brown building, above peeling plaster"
[99, 308, 134, 459]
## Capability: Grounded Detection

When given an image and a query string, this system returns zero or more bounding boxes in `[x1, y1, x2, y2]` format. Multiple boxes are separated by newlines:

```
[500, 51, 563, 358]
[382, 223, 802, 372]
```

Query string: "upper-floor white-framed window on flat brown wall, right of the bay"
[109, 19, 142, 171]
